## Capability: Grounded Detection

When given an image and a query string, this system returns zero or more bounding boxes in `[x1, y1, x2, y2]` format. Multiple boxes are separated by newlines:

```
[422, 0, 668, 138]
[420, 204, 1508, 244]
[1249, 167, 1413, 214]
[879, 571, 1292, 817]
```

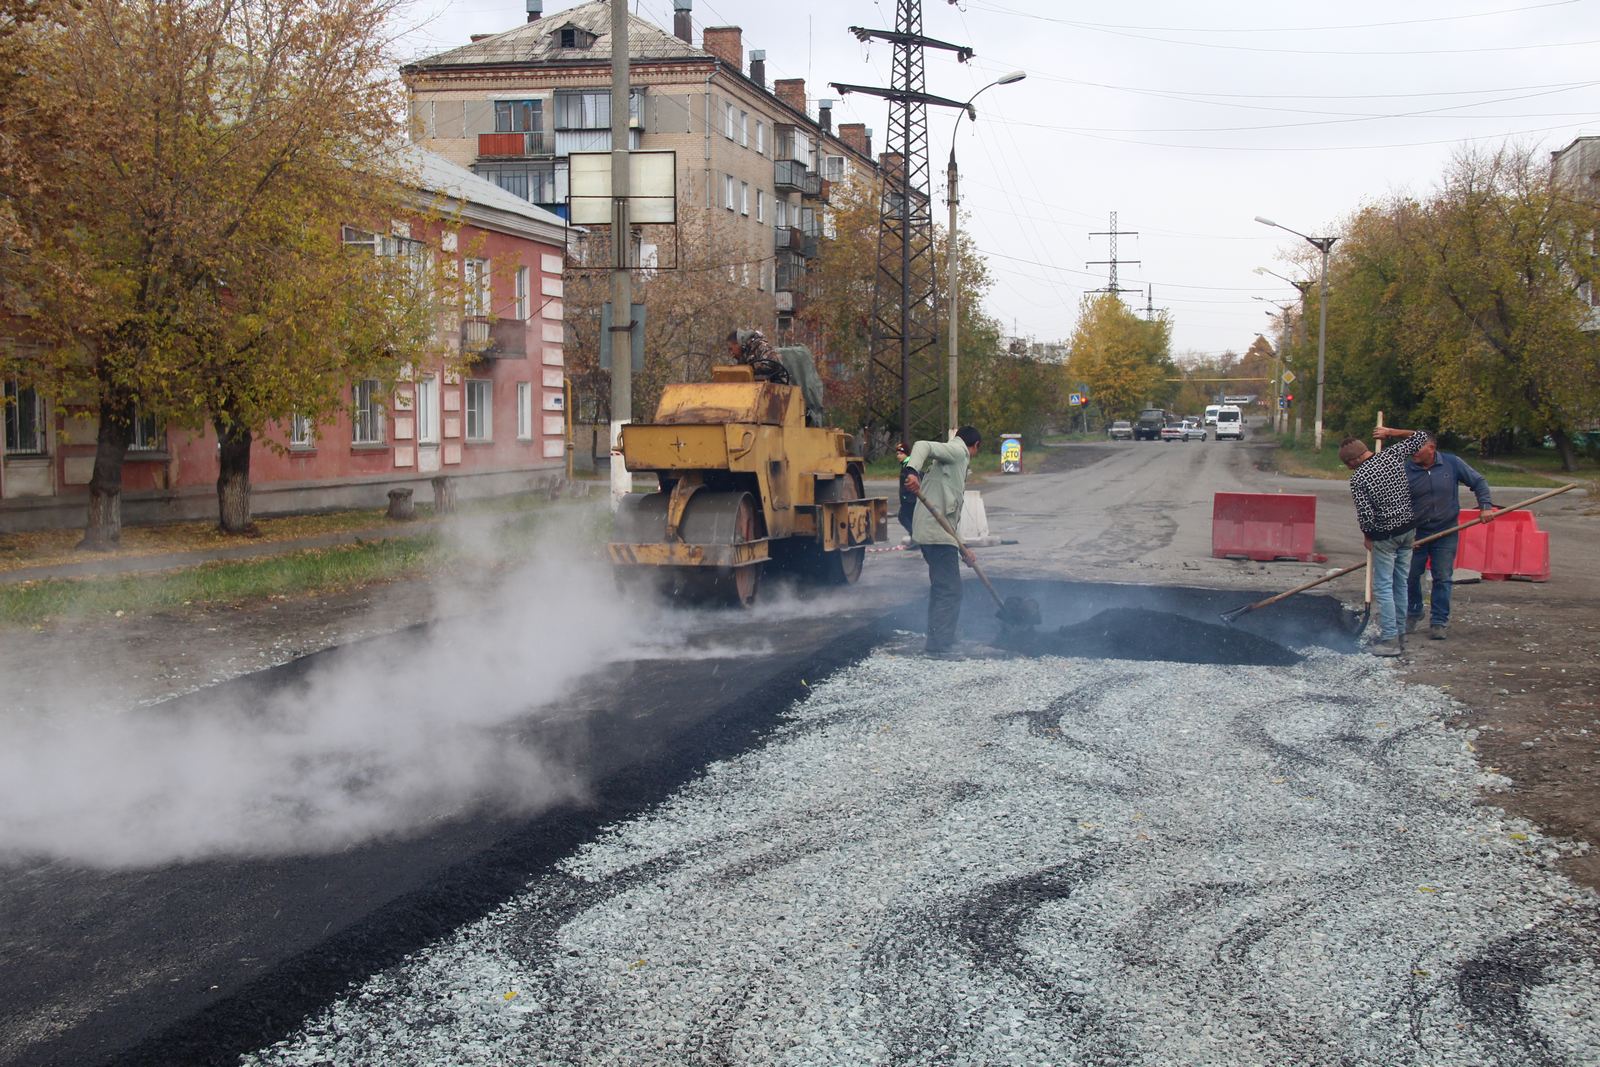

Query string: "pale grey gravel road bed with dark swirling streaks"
[243, 651, 1600, 1067]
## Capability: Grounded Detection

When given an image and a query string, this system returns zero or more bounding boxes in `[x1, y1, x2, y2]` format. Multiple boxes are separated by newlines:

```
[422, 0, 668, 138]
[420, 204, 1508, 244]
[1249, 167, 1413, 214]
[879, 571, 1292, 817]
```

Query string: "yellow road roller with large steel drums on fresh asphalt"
[608, 366, 888, 605]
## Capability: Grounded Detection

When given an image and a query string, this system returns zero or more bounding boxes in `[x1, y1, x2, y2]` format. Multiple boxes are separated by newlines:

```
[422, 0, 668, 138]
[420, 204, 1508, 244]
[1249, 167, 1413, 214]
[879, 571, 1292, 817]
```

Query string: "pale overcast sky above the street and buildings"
[402, 0, 1600, 361]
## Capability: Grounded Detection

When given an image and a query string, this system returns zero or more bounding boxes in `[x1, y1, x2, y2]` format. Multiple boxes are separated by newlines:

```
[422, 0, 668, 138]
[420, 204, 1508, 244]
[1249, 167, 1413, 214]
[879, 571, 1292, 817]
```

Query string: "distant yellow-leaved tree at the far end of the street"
[1067, 293, 1176, 419]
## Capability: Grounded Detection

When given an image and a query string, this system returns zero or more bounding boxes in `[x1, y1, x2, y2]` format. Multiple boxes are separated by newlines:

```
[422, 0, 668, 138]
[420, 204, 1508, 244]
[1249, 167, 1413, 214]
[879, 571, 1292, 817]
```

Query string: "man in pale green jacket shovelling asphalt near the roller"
[904, 426, 982, 656]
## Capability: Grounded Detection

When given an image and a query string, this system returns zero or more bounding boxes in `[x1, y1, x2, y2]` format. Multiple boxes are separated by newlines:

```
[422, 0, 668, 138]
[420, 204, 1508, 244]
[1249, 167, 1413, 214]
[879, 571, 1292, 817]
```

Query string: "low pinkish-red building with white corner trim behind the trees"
[0, 147, 566, 531]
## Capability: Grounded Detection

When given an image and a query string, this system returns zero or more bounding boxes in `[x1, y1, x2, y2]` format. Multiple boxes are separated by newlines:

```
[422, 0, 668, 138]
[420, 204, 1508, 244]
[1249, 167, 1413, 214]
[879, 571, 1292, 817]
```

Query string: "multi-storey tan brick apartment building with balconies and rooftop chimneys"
[402, 0, 874, 334]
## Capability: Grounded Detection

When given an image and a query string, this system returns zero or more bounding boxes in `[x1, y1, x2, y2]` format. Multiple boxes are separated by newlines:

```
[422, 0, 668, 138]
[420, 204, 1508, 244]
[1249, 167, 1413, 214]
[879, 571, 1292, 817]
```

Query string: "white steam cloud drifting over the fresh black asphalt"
[0, 511, 748, 867]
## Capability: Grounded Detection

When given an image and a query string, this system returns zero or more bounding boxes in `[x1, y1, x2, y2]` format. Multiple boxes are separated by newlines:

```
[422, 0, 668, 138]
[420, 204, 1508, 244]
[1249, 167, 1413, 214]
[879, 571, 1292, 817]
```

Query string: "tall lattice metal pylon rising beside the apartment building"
[834, 0, 973, 443]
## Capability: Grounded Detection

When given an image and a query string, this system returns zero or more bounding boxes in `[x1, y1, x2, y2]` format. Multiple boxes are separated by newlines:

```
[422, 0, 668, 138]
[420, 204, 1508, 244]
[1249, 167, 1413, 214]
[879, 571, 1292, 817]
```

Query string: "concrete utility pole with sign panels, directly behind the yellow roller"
[611, 0, 635, 510]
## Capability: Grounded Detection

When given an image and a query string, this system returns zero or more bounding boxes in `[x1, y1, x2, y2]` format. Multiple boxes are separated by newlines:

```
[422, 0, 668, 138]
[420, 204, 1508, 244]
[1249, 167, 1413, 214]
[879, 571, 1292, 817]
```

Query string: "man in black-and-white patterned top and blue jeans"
[1339, 426, 1427, 656]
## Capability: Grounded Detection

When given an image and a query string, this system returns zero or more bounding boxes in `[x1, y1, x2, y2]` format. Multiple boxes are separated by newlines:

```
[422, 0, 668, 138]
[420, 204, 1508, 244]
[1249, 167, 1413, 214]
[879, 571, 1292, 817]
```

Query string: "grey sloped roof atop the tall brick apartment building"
[405, 0, 697, 70]
